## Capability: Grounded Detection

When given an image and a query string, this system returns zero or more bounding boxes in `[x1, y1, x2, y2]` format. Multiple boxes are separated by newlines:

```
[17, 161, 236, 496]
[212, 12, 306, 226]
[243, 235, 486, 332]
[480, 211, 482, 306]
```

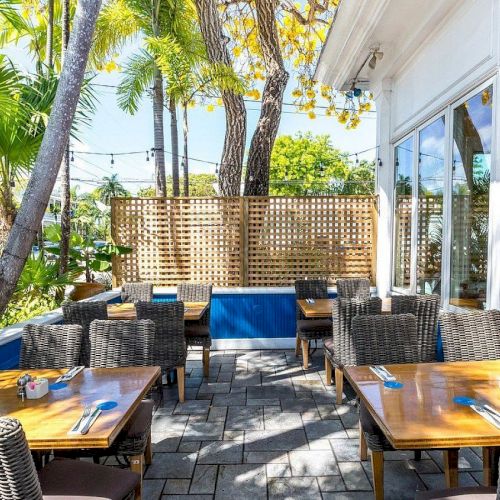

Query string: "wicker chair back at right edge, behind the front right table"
[440, 310, 500, 361]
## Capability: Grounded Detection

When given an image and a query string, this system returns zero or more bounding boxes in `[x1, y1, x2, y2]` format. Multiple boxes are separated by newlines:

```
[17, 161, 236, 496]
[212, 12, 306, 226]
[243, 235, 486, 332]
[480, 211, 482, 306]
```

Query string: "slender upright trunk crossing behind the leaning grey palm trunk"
[59, 0, 71, 276]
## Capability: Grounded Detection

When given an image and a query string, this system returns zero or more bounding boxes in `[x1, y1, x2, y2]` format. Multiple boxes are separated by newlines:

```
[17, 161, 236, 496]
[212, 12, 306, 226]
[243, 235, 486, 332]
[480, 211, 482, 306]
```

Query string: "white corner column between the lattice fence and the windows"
[375, 80, 394, 297]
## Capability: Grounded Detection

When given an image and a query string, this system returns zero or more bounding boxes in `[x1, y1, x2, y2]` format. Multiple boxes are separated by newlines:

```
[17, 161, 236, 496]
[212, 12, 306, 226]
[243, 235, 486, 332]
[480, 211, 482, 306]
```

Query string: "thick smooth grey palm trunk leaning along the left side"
[0, 0, 101, 314]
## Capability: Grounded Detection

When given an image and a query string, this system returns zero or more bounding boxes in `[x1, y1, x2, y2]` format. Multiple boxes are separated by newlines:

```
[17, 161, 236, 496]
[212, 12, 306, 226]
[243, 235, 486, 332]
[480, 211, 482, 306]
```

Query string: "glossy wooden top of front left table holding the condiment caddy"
[0, 366, 161, 450]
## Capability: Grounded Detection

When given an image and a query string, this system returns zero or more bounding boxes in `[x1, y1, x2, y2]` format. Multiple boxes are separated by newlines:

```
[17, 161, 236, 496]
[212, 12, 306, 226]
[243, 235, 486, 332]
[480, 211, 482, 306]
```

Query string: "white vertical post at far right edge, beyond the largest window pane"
[487, 74, 500, 309]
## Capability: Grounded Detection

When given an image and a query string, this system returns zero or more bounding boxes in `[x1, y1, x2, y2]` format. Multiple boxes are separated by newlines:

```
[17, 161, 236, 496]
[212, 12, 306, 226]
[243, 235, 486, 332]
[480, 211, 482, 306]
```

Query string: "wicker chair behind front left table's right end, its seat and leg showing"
[90, 319, 155, 481]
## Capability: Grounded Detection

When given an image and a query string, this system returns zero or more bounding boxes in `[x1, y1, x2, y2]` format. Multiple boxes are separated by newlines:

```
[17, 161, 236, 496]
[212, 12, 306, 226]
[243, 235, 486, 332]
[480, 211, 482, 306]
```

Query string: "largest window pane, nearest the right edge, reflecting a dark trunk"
[450, 87, 493, 309]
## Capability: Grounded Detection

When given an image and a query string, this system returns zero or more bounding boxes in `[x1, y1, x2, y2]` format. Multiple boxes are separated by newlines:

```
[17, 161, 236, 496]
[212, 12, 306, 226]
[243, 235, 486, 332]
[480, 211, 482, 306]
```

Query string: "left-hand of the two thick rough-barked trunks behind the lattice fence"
[196, 0, 247, 196]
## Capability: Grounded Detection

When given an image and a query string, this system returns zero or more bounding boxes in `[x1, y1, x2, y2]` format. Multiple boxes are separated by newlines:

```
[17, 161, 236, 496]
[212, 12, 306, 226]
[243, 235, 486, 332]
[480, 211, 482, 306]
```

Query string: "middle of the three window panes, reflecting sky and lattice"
[417, 116, 445, 294]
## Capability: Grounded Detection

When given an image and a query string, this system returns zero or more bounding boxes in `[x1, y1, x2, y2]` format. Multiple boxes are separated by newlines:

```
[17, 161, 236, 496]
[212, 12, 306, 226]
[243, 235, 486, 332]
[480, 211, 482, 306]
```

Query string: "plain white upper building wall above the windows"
[391, 0, 500, 141]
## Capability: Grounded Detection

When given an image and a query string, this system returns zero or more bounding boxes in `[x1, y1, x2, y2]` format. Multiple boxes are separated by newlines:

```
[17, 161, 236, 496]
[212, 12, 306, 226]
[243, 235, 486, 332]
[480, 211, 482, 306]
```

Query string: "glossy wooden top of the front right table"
[344, 360, 500, 449]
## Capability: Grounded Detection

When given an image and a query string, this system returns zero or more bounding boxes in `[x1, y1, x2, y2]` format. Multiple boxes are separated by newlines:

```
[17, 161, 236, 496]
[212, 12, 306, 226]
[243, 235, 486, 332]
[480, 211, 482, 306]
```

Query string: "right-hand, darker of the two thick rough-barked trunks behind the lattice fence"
[245, 0, 288, 196]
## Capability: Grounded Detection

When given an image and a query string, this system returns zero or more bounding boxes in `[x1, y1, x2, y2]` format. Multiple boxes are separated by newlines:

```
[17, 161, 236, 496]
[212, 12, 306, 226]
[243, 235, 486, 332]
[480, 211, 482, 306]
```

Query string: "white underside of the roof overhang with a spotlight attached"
[315, 0, 460, 90]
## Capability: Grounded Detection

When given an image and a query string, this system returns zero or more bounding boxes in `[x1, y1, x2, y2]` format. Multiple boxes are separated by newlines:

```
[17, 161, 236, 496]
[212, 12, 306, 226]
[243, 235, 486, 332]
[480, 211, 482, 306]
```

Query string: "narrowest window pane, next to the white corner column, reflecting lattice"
[394, 138, 413, 288]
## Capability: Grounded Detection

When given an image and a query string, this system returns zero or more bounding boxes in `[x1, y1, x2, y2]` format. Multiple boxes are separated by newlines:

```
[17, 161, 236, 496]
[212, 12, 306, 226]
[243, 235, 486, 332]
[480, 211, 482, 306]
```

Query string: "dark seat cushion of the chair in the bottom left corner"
[39, 458, 140, 500]
